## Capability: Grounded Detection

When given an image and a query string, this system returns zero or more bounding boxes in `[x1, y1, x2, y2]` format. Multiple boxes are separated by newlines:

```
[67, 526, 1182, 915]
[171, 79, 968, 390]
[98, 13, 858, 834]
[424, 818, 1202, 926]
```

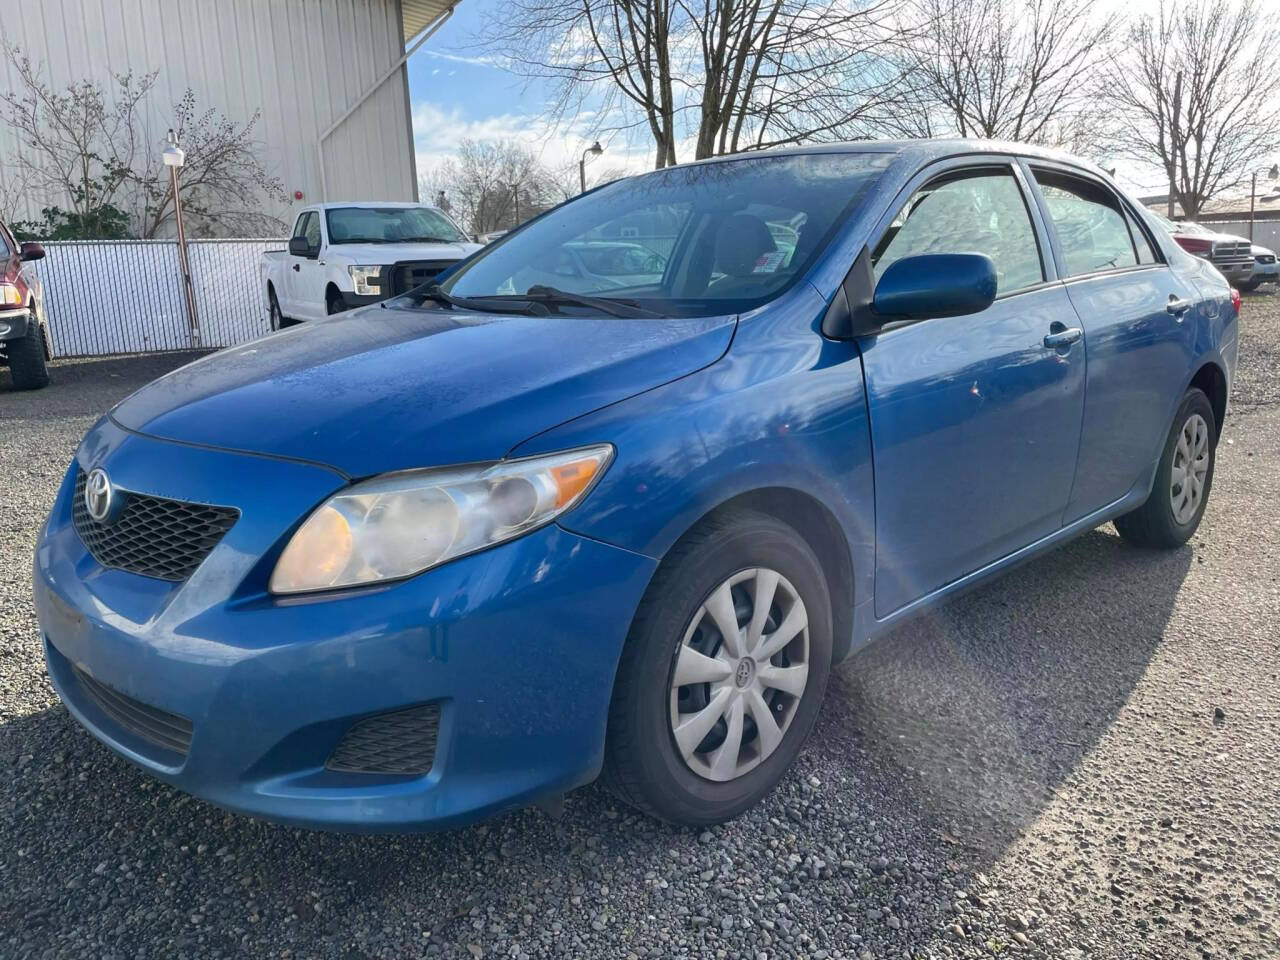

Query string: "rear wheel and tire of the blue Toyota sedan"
[1115, 387, 1217, 549]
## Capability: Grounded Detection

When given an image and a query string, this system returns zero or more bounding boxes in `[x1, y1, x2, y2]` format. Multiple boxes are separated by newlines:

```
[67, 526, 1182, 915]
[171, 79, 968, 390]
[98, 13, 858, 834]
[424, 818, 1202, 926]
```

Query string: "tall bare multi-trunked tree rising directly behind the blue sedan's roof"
[484, 0, 899, 168]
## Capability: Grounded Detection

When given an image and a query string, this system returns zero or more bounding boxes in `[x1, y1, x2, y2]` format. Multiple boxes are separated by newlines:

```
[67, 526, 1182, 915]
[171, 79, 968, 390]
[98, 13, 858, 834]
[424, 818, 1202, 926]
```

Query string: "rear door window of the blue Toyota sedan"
[1034, 170, 1155, 276]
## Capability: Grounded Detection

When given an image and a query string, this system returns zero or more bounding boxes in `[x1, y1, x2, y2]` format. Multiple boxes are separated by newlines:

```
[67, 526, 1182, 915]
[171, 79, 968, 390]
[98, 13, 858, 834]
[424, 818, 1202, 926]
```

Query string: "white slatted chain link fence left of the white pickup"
[35, 239, 285, 357]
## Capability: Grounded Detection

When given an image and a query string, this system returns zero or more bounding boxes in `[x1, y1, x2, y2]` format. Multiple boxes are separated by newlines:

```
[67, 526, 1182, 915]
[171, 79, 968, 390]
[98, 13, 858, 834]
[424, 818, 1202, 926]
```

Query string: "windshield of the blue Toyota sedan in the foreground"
[442, 152, 892, 316]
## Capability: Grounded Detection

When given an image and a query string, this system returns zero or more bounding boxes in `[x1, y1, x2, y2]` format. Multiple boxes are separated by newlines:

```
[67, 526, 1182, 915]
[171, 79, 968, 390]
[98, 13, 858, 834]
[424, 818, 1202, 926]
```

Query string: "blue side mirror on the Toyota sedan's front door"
[872, 253, 996, 321]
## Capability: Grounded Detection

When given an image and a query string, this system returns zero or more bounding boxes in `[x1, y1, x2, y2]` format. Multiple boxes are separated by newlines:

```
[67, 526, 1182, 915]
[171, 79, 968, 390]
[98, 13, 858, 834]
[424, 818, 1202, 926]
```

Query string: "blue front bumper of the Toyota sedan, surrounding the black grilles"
[35, 422, 654, 831]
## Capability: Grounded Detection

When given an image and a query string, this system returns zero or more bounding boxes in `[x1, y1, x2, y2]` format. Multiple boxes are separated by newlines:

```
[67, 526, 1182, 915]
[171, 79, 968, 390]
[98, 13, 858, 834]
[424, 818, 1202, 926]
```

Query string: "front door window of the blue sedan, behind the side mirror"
[872, 169, 1044, 296]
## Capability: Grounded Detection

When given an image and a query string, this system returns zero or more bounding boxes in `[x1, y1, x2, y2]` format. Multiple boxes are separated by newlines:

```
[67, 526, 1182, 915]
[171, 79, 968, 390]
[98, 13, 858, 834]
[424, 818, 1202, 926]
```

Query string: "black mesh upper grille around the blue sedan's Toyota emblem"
[72, 470, 239, 582]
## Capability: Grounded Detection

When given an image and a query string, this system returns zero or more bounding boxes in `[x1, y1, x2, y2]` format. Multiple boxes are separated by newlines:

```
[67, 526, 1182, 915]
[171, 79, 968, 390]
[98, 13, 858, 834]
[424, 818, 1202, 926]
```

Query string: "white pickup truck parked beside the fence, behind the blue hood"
[259, 202, 480, 330]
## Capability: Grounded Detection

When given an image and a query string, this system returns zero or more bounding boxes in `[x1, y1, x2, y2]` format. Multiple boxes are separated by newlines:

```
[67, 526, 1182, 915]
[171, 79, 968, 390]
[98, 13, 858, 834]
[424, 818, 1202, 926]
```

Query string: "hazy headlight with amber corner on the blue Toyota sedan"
[270, 444, 613, 594]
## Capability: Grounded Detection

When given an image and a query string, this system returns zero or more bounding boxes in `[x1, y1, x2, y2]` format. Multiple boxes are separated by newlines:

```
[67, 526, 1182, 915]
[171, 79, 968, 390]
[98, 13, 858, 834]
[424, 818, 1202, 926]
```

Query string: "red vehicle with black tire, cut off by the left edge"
[0, 221, 49, 390]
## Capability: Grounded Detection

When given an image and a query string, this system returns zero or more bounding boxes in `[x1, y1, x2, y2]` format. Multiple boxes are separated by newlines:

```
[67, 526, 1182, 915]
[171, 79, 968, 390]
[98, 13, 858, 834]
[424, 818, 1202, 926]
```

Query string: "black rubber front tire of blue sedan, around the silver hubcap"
[621, 515, 832, 823]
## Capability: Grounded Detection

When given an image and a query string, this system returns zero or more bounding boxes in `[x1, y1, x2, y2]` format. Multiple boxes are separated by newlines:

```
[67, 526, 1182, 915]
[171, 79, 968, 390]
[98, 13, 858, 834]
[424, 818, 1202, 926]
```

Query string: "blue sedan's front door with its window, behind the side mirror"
[859, 157, 1084, 617]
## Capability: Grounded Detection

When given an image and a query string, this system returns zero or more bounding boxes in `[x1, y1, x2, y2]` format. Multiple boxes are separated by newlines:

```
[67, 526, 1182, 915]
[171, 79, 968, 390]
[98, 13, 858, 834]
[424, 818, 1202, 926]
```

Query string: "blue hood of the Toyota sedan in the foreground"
[111, 306, 735, 477]
